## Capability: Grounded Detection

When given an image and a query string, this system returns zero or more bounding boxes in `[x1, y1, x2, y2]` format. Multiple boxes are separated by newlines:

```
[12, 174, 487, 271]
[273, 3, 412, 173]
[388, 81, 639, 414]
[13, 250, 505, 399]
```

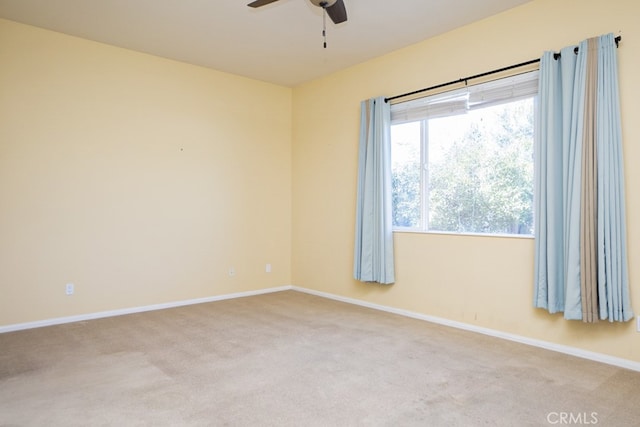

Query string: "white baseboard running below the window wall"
[291, 286, 640, 372]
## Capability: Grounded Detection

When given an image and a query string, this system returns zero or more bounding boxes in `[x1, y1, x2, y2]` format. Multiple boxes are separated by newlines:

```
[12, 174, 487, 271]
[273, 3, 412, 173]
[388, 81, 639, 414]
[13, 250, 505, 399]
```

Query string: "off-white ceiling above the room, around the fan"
[0, 0, 531, 87]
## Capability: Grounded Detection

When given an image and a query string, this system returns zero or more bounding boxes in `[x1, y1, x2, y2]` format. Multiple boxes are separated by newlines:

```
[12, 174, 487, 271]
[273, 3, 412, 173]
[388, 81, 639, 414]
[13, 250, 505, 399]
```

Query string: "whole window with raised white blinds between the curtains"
[391, 71, 538, 235]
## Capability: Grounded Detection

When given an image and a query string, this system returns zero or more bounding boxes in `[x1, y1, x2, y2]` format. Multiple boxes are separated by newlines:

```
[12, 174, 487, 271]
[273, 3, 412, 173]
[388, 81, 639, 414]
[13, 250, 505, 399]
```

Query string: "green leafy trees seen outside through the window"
[393, 100, 533, 234]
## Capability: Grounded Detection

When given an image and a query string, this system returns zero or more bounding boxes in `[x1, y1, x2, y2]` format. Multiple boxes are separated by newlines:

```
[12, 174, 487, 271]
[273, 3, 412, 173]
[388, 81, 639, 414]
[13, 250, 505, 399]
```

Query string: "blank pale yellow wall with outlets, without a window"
[0, 16, 292, 325]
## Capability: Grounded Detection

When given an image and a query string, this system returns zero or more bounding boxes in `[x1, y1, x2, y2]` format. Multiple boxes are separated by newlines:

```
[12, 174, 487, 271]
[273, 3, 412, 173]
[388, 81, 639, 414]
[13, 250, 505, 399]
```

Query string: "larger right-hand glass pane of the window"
[427, 98, 533, 234]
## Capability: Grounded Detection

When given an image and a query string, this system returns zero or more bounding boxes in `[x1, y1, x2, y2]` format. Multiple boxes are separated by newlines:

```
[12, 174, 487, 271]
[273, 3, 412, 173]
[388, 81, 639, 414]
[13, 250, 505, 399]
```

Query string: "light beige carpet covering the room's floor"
[0, 291, 640, 427]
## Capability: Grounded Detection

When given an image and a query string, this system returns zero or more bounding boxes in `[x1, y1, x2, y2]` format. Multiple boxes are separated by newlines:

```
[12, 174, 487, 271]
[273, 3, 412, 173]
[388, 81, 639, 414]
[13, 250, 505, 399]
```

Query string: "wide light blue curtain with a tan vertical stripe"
[534, 34, 634, 322]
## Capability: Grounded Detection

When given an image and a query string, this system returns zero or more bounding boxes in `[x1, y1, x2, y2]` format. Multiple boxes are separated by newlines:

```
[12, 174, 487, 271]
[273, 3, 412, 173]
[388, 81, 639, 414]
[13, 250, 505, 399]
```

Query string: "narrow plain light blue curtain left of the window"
[353, 97, 395, 284]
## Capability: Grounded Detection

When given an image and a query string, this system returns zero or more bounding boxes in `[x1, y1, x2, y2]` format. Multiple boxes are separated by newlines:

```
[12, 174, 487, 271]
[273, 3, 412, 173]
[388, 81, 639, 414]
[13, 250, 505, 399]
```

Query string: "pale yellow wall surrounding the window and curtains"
[292, 0, 640, 361]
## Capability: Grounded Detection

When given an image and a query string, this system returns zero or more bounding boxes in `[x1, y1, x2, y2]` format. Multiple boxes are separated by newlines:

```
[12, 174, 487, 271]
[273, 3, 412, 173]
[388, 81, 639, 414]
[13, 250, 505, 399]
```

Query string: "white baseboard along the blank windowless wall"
[0, 286, 291, 334]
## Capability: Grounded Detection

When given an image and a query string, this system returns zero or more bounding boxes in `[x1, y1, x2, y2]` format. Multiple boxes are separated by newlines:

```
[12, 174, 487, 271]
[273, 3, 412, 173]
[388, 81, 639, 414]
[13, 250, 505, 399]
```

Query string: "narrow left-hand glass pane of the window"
[391, 121, 422, 228]
